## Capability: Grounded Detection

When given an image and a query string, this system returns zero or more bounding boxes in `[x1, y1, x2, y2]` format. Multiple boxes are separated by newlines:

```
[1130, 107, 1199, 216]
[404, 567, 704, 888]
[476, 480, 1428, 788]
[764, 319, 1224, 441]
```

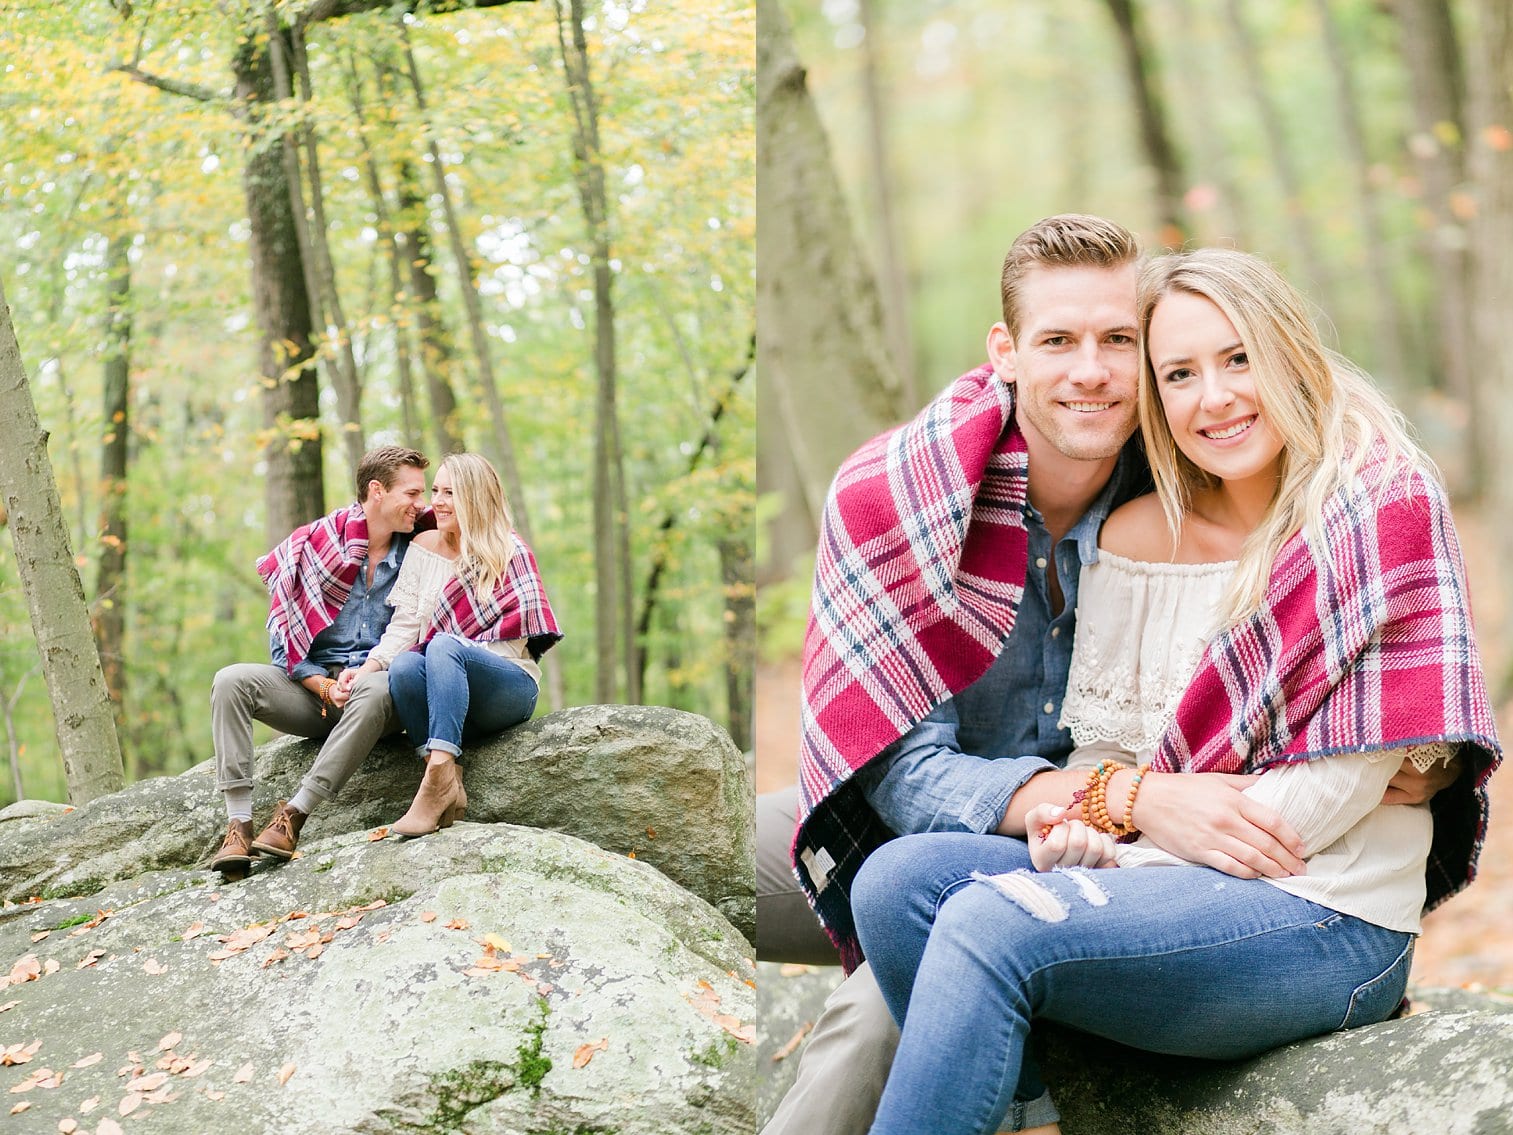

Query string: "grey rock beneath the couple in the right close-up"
[757, 962, 1513, 1135]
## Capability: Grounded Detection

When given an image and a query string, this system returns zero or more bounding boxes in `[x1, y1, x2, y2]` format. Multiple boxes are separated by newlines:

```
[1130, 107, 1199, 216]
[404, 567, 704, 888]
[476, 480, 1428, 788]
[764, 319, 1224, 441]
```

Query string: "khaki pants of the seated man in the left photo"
[210, 663, 399, 801]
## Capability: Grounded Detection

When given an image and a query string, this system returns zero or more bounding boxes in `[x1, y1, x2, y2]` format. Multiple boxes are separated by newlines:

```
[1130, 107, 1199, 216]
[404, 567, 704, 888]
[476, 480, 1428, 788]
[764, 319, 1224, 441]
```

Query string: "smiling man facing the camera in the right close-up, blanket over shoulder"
[757, 215, 1452, 1135]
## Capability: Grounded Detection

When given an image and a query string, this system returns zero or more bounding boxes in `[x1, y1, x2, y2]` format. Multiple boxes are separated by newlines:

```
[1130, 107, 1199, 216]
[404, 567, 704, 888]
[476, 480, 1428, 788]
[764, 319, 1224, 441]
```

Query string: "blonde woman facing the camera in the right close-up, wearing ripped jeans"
[852, 250, 1498, 1135]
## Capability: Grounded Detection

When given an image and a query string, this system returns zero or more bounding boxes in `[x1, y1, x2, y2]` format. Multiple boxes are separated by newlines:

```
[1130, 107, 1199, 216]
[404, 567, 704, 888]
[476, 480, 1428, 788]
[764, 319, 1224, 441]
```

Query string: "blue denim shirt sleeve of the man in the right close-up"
[856, 701, 1056, 835]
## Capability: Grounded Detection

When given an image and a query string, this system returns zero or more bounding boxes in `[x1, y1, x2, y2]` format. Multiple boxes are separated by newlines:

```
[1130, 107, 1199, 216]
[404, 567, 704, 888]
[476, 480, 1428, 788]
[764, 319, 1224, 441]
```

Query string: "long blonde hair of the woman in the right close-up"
[1136, 248, 1439, 627]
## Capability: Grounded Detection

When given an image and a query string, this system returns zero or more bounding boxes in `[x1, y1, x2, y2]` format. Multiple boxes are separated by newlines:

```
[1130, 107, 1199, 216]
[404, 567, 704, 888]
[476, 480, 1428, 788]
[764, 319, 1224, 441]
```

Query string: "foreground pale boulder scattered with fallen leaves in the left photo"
[0, 822, 755, 1135]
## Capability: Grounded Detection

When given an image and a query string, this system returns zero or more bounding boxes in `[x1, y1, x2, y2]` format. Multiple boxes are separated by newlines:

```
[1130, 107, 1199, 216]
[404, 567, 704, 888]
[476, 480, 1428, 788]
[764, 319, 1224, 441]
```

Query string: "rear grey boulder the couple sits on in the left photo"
[0, 705, 757, 938]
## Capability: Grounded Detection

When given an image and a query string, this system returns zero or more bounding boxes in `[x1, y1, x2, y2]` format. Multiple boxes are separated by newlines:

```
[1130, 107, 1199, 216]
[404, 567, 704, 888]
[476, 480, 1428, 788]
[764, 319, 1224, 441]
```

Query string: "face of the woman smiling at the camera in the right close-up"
[1147, 292, 1282, 483]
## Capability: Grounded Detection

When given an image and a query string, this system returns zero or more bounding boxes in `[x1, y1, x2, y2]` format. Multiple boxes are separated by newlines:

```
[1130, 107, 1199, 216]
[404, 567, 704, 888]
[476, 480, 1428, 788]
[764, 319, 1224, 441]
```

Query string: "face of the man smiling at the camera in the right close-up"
[988, 265, 1139, 462]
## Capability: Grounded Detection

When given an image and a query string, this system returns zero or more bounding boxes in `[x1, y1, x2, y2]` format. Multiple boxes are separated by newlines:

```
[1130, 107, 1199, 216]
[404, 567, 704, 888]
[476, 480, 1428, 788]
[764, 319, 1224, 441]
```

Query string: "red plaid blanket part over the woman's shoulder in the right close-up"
[1153, 460, 1502, 910]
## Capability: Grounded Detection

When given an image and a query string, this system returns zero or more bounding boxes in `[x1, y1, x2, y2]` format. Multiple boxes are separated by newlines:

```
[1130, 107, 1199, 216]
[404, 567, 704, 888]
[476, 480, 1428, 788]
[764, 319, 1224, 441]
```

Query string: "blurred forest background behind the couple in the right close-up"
[757, 0, 1513, 988]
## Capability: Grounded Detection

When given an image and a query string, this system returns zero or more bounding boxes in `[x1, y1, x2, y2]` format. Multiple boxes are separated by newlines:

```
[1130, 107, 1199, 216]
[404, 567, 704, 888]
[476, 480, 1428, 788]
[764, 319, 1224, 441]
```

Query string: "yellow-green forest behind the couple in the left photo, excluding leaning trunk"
[0, 0, 755, 804]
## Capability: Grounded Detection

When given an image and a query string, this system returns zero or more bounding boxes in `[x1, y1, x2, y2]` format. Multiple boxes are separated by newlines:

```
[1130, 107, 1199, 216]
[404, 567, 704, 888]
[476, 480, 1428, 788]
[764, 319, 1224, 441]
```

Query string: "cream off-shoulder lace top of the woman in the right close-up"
[1061, 551, 1452, 934]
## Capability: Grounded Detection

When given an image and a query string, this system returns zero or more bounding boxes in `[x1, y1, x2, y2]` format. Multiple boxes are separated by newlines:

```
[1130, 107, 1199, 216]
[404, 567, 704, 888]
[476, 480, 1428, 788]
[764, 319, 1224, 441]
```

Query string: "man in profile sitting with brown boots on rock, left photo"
[210, 445, 430, 878]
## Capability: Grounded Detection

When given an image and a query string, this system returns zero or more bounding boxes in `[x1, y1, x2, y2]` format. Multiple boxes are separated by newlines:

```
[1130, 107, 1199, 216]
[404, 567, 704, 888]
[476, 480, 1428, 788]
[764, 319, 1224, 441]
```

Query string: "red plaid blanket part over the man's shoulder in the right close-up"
[793, 366, 1029, 970]
